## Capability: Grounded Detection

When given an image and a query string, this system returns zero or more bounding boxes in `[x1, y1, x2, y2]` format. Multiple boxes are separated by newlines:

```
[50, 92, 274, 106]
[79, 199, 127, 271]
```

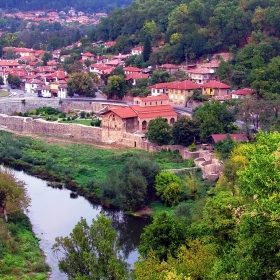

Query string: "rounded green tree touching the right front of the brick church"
[146, 117, 171, 145]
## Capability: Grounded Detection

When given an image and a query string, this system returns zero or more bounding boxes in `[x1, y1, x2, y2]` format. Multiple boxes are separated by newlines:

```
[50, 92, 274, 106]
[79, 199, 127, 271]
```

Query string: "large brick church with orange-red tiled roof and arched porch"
[102, 96, 177, 144]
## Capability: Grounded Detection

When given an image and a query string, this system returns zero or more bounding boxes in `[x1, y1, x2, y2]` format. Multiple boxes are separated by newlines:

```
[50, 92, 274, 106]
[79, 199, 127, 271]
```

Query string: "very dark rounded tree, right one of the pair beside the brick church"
[172, 116, 200, 146]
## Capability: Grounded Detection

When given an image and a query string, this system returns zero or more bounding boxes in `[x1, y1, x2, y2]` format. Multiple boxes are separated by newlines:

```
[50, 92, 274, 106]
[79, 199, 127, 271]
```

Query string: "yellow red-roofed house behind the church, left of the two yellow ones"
[166, 80, 200, 106]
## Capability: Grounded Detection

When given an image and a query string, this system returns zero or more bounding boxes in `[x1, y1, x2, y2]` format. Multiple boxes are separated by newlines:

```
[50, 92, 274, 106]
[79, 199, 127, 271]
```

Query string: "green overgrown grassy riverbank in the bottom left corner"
[0, 213, 49, 280]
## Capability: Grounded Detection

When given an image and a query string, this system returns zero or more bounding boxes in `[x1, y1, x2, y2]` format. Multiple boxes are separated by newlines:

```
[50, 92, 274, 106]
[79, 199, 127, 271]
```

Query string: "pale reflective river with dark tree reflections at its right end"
[14, 171, 148, 280]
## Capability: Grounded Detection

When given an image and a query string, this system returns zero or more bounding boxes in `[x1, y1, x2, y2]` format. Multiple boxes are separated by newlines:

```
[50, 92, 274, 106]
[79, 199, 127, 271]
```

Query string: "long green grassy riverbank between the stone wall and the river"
[0, 131, 194, 204]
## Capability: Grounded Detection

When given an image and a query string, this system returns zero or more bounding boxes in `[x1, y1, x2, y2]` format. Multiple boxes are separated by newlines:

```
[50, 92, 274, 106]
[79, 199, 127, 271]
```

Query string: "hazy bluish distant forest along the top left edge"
[0, 0, 131, 13]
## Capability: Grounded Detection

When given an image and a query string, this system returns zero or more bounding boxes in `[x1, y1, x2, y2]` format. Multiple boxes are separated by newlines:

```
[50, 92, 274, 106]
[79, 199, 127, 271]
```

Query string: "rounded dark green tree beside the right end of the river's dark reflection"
[139, 211, 188, 260]
